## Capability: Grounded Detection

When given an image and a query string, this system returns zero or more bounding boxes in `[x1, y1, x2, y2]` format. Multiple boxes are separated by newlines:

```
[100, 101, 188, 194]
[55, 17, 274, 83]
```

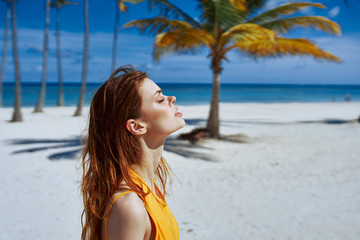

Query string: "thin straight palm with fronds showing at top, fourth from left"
[50, 0, 77, 106]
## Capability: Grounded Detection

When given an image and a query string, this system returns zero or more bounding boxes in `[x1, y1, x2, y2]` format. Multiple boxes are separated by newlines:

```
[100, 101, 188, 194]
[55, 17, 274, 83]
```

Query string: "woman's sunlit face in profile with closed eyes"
[140, 78, 185, 137]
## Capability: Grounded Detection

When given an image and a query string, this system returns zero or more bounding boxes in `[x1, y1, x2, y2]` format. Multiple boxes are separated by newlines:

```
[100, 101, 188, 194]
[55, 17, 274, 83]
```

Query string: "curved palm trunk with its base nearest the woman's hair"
[74, 0, 89, 116]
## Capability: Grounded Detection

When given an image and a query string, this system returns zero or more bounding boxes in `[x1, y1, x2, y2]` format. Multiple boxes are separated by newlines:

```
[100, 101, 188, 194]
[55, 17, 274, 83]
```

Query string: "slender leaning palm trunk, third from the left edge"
[34, 0, 50, 113]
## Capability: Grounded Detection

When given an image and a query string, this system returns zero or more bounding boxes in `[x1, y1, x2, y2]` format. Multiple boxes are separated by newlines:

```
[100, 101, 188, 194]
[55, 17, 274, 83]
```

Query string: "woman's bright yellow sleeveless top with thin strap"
[105, 170, 180, 240]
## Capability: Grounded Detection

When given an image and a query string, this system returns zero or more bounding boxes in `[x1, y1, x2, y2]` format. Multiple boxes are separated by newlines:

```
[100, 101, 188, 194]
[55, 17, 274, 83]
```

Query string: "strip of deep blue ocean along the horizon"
[3, 82, 360, 107]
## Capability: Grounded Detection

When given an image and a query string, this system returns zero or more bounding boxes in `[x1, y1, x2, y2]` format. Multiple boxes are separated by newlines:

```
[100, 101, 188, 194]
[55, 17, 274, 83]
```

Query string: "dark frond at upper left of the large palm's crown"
[148, 0, 200, 28]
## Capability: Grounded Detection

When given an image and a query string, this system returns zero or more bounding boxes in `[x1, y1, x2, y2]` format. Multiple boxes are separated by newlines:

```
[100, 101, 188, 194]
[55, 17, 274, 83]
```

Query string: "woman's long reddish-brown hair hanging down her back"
[81, 65, 169, 240]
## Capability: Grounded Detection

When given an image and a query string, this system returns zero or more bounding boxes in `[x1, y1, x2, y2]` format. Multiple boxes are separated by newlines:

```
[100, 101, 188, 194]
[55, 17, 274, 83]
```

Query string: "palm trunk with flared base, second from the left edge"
[11, 0, 23, 122]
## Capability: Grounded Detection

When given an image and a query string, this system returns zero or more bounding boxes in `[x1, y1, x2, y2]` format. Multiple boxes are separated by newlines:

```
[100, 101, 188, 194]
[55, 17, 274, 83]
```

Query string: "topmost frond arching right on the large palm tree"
[247, 2, 326, 24]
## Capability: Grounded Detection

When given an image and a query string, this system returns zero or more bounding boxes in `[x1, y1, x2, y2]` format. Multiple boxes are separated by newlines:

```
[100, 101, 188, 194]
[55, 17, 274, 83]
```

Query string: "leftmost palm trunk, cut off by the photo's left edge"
[0, 0, 11, 107]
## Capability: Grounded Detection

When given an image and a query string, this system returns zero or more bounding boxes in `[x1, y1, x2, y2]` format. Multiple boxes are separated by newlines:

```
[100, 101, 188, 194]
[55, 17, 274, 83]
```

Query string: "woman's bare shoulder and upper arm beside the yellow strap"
[107, 192, 149, 240]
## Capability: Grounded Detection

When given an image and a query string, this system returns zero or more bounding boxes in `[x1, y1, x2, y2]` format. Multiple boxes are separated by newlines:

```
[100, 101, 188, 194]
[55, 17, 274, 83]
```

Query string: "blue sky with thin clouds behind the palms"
[0, 0, 360, 85]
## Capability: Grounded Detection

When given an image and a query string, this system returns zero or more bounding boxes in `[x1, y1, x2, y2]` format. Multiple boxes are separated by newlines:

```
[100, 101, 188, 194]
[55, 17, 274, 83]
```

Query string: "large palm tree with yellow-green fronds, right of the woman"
[124, 0, 341, 138]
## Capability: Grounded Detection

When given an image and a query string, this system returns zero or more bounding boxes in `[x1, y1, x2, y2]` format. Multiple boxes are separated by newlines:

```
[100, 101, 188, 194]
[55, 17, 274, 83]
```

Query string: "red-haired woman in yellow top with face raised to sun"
[81, 66, 185, 240]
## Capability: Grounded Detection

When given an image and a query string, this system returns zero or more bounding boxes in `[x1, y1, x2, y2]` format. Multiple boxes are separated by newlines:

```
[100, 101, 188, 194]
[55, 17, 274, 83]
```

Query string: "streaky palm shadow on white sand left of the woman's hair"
[8, 136, 85, 161]
